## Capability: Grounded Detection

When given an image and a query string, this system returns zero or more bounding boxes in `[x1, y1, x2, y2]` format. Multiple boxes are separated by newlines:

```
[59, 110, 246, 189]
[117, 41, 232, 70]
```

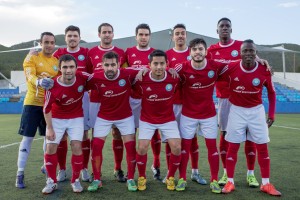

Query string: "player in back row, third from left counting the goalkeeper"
[88, 23, 126, 182]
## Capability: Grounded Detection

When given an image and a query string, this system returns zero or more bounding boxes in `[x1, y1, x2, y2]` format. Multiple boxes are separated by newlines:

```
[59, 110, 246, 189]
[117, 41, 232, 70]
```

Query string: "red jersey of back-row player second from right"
[166, 48, 191, 104]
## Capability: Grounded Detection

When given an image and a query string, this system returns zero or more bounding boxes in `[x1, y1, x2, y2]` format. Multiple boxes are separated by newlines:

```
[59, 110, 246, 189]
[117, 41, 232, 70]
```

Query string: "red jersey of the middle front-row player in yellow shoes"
[135, 72, 179, 124]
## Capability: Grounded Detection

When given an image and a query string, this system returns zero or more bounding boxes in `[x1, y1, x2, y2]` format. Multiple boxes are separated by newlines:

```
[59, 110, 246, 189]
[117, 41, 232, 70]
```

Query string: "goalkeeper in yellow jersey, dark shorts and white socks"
[16, 32, 58, 189]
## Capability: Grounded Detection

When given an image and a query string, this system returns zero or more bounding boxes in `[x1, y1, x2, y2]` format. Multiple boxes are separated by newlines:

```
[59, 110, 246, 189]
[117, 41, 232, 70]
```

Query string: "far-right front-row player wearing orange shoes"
[222, 40, 281, 196]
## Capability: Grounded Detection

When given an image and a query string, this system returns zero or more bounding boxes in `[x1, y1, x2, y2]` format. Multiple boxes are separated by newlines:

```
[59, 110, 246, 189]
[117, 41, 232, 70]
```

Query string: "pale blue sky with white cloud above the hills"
[0, 0, 300, 46]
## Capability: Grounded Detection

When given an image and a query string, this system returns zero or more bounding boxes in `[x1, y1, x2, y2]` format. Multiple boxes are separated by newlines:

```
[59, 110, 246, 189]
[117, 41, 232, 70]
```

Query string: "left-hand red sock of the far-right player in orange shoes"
[226, 142, 240, 178]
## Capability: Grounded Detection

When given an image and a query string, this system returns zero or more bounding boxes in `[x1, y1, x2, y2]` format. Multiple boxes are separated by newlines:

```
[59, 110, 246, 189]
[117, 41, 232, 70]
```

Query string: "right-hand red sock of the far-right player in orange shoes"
[256, 143, 270, 178]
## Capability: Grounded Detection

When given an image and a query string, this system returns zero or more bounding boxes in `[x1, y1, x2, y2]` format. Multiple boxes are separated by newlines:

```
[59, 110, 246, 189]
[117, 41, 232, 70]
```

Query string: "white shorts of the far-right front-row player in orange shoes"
[225, 105, 270, 144]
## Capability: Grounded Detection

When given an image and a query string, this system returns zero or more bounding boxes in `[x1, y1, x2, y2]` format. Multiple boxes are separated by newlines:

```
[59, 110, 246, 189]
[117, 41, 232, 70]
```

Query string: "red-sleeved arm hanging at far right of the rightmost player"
[264, 72, 276, 127]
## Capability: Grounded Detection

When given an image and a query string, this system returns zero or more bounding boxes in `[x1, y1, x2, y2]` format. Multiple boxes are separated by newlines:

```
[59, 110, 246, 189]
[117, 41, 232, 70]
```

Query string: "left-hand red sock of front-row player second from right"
[179, 138, 192, 180]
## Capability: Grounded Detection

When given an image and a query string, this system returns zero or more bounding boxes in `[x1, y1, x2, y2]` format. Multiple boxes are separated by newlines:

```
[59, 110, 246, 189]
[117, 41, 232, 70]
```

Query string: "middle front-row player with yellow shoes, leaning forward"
[134, 50, 181, 190]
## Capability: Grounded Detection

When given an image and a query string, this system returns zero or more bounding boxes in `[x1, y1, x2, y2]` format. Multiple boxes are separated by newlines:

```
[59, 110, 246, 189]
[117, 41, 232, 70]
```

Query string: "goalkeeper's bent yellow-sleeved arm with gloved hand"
[23, 55, 54, 90]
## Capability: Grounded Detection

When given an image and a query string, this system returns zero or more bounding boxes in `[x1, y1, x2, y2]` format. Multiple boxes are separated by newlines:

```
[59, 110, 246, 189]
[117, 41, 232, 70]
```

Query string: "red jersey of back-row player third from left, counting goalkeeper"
[88, 46, 125, 103]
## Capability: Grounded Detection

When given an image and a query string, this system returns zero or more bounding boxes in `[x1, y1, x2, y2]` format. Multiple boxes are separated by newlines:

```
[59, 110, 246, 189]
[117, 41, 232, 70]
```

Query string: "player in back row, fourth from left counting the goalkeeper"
[125, 24, 161, 180]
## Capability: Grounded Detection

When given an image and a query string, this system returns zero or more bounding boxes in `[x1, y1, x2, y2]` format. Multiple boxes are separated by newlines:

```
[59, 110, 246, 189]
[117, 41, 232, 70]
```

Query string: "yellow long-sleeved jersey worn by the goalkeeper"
[23, 52, 58, 106]
